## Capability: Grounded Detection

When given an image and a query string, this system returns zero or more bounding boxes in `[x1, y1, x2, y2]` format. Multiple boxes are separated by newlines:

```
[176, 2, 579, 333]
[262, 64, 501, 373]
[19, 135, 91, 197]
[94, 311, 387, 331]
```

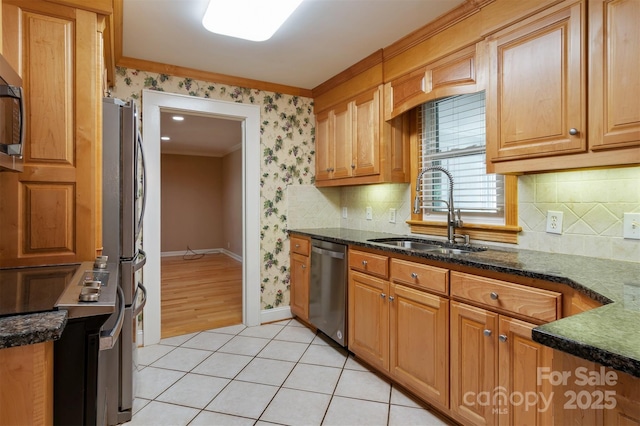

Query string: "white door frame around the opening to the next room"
[142, 90, 261, 345]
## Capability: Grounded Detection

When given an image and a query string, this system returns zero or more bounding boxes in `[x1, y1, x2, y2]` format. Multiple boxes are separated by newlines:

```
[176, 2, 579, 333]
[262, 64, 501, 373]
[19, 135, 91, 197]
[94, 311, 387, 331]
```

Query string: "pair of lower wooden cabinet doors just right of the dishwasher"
[349, 264, 449, 409]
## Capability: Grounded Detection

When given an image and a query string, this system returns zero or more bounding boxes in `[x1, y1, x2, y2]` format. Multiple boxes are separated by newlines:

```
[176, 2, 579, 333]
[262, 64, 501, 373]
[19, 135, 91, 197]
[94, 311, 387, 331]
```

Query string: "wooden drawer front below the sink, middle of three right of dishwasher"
[391, 259, 449, 294]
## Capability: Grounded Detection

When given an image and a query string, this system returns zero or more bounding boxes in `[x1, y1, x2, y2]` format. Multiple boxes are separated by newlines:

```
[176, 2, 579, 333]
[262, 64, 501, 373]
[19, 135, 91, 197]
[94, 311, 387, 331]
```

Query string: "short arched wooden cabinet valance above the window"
[384, 43, 485, 120]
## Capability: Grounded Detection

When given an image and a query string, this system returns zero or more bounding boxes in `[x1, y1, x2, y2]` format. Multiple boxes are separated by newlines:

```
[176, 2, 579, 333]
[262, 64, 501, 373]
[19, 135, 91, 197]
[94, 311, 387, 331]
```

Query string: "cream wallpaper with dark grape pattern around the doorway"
[112, 68, 315, 309]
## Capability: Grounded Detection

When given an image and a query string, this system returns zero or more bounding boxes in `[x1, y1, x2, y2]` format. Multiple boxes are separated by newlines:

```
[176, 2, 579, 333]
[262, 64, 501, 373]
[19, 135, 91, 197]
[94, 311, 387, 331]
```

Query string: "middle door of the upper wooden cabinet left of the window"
[330, 103, 354, 179]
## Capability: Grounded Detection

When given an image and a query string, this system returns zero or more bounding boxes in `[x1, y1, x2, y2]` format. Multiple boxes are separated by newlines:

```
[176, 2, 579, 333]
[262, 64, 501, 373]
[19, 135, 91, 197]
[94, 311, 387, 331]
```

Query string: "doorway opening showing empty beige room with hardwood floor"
[160, 108, 242, 339]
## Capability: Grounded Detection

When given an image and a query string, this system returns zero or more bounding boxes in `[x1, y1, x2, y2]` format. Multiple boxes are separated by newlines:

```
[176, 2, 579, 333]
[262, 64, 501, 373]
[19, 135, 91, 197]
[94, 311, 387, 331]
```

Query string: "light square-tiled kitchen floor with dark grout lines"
[127, 320, 456, 426]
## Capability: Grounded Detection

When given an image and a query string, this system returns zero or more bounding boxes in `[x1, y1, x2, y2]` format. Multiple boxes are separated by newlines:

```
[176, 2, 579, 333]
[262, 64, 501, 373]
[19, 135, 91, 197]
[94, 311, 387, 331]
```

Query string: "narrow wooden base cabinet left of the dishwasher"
[289, 236, 311, 321]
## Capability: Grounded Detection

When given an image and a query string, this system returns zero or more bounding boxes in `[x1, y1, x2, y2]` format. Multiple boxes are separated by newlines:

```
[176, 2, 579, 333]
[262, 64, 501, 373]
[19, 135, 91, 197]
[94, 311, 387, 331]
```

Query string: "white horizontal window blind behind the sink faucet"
[418, 92, 504, 222]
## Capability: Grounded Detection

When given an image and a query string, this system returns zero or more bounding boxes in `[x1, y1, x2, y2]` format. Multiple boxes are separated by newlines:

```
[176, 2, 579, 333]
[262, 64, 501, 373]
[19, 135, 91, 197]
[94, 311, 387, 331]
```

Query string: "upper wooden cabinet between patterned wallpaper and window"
[313, 50, 409, 186]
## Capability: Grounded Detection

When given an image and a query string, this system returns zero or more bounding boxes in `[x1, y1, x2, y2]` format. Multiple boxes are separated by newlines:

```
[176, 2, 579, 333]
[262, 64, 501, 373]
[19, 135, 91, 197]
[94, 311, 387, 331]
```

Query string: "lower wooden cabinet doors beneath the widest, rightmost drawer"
[451, 301, 553, 425]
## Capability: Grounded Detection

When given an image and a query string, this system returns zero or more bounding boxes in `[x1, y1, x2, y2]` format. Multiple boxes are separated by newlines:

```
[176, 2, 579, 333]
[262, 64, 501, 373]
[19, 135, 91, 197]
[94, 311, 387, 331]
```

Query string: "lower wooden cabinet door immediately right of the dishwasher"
[349, 271, 389, 371]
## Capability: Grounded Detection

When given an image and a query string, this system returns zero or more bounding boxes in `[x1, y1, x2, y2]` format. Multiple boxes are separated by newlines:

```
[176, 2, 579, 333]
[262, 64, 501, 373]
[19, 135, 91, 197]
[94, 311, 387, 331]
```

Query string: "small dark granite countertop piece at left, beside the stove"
[0, 310, 67, 349]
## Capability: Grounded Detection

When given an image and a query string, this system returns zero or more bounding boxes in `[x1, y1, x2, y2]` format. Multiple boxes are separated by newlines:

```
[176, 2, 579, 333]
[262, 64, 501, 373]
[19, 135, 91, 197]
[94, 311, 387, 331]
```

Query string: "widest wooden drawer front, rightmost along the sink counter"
[451, 272, 562, 322]
